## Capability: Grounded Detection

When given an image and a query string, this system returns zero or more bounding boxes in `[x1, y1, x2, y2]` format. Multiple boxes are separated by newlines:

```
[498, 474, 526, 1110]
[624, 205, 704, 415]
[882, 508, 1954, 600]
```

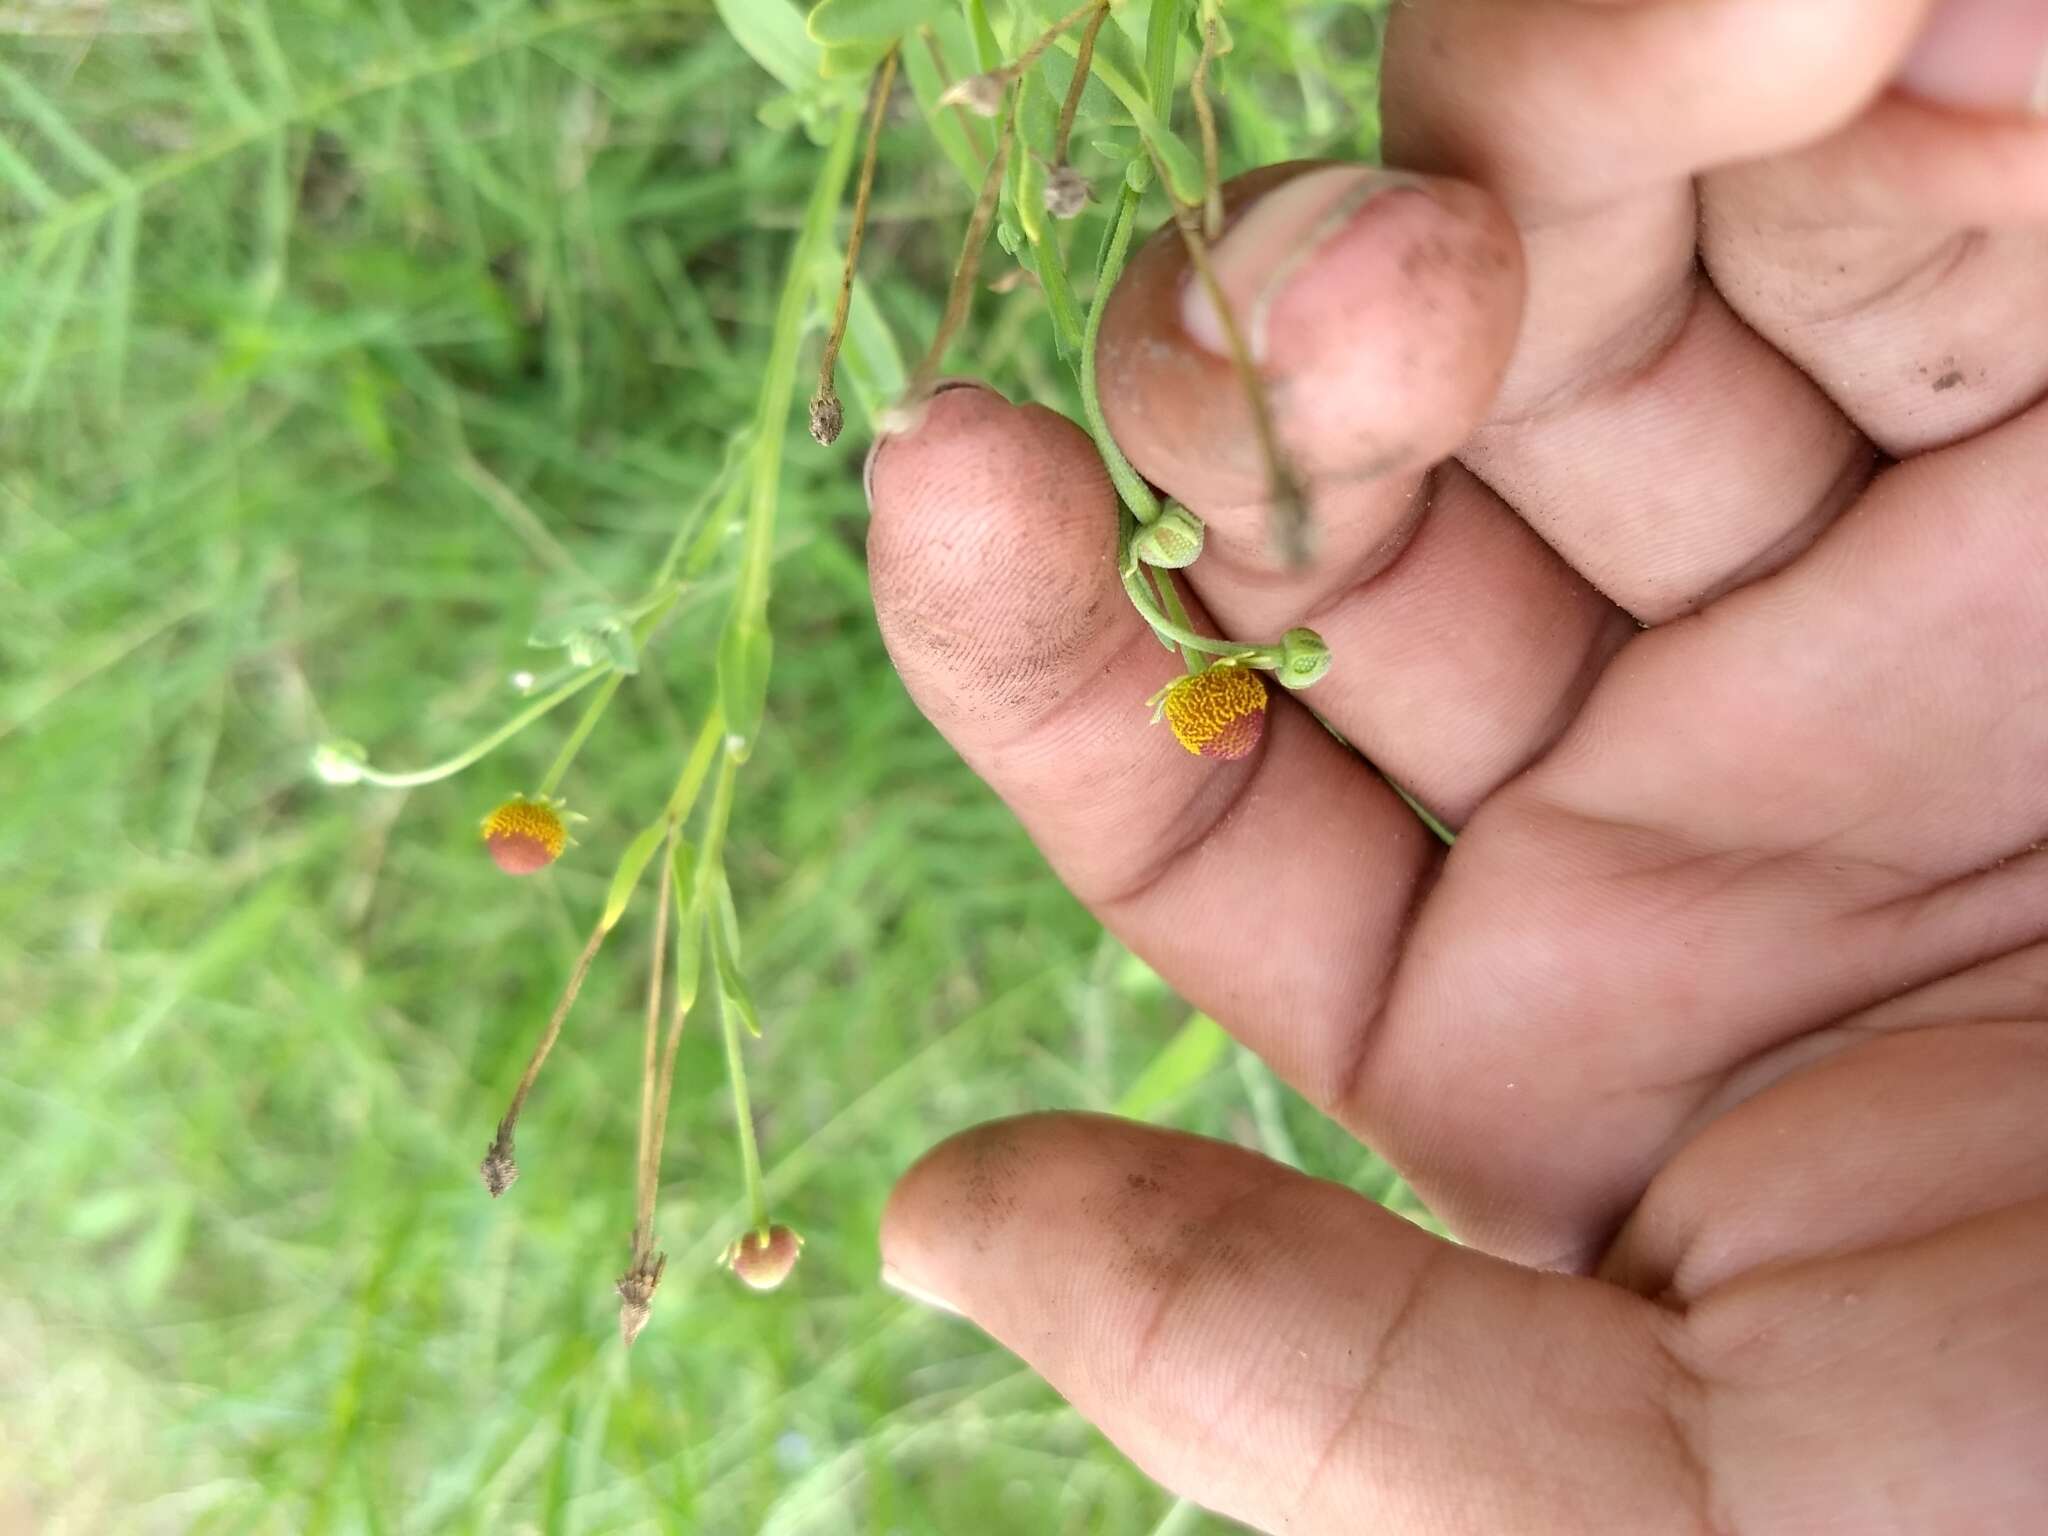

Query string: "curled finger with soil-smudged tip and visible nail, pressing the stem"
[1098, 166, 1630, 823]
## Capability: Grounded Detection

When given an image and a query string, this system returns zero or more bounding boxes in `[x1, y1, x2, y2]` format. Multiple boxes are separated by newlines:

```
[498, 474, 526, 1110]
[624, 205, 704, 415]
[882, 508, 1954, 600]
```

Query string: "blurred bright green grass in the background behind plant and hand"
[0, 0, 1393, 1536]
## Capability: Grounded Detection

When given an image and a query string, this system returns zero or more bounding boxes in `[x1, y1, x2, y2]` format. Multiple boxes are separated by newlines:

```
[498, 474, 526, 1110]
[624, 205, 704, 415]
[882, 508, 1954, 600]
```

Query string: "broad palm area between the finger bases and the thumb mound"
[1350, 408, 2048, 1266]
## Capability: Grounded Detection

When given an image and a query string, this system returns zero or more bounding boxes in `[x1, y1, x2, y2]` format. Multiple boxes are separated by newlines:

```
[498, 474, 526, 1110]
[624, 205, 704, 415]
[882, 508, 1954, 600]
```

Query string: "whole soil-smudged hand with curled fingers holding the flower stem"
[870, 0, 2048, 1536]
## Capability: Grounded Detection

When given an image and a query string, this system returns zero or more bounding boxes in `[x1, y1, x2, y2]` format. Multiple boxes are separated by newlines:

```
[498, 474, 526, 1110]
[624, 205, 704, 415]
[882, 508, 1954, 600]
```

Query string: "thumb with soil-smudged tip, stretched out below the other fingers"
[883, 1114, 1706, 1532]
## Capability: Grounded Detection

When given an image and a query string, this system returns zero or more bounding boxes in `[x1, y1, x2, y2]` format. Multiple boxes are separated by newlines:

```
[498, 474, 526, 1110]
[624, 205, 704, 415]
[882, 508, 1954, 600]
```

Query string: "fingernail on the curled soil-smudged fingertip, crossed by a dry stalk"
[1180, 166, 1421, 362]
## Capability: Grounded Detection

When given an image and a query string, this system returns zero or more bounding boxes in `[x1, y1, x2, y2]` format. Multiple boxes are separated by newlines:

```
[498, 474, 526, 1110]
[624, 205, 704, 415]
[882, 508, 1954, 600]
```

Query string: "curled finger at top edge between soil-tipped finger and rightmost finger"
[1384, 0, 1923, 623]
